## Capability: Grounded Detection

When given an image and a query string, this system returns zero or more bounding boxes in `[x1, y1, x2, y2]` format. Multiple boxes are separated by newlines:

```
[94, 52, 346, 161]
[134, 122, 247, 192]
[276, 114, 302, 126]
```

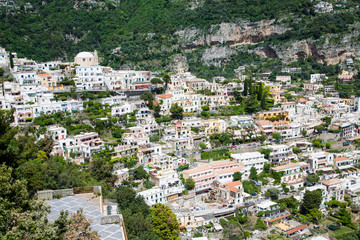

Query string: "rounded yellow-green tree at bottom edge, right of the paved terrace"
[151, 203, 180, 240]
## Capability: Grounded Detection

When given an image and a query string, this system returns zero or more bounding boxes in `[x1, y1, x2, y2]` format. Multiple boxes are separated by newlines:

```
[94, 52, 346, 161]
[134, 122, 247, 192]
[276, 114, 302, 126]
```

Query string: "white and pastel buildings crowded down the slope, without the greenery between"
[0, 49, 360, 236]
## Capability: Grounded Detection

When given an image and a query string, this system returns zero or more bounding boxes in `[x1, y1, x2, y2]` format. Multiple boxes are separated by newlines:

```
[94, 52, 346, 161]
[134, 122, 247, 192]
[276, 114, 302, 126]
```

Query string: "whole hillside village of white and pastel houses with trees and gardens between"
[0, 45, 360, 240]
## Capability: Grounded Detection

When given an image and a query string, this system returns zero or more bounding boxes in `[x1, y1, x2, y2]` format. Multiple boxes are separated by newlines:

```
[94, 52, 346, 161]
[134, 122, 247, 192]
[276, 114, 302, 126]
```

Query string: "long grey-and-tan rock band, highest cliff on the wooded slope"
[175, 20, 287, 49]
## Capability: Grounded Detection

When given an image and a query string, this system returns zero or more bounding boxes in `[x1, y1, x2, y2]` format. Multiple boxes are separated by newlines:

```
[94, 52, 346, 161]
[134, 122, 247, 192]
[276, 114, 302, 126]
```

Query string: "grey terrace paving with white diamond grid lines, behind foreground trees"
[46, 194, 123, 240]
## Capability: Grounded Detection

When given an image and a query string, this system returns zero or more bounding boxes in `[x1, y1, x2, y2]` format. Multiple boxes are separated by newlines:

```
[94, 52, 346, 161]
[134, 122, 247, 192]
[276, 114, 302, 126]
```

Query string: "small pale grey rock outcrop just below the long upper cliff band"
[201, 46, 235, 67]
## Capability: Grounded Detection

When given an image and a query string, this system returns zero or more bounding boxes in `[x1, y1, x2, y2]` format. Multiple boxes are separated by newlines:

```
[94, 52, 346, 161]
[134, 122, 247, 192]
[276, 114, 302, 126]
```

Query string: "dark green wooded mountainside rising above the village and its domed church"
[0, 0, 360, 76]
